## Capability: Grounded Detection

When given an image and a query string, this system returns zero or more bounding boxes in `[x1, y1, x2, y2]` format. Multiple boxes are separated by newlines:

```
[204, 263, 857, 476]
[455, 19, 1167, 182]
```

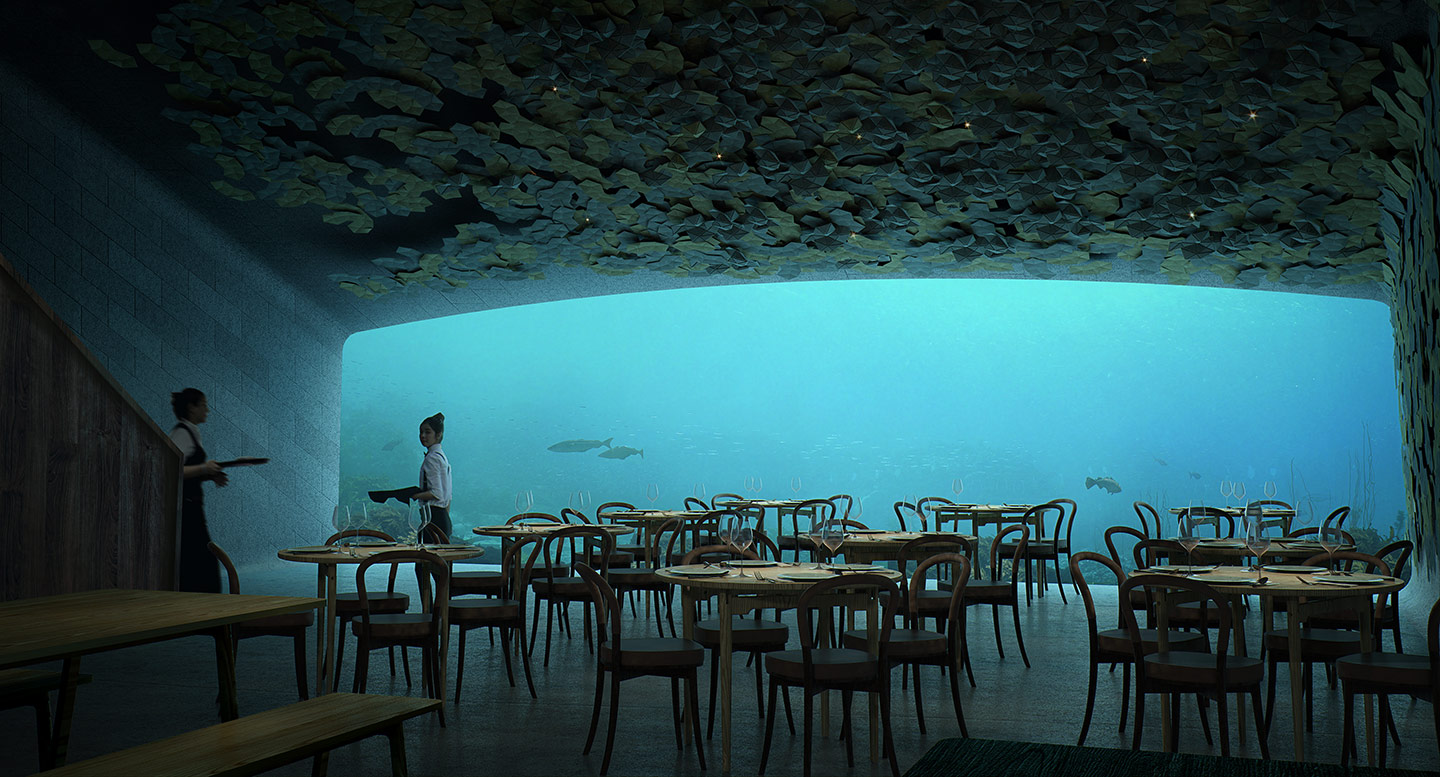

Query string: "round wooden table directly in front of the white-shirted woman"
[275, 542, 485, 695]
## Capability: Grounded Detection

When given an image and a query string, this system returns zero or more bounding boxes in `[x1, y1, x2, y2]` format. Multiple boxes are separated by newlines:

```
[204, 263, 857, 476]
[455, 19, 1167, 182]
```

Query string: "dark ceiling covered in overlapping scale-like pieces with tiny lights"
[25, 0, 1428, 296]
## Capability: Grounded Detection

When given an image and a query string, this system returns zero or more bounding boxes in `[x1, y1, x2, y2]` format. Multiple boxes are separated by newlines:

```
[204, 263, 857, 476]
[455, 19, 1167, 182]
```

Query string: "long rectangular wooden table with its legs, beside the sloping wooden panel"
[0, 589, 321, 765]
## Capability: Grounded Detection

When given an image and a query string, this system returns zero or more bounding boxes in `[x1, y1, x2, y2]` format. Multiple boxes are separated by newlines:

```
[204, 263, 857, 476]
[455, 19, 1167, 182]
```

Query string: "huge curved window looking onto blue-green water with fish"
[338, 279, 1405, 561]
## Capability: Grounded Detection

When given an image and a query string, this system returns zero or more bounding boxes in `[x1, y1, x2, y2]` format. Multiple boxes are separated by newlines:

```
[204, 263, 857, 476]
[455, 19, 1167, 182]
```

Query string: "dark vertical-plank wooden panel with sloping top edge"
[0, 256, 180, 600]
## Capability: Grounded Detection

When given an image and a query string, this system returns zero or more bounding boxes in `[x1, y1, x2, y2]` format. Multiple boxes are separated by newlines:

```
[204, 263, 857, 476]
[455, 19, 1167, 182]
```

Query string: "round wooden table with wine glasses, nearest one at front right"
[1138, 565, 1405, 764]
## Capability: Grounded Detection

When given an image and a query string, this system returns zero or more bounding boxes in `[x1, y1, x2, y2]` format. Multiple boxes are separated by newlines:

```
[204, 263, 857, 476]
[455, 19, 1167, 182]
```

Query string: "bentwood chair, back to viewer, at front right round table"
[1120, 574, 1270, 758]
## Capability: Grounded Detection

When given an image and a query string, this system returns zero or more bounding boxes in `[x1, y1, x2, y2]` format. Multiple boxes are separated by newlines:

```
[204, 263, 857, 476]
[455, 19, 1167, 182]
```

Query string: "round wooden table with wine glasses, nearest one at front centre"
[657, 563, 900, 773]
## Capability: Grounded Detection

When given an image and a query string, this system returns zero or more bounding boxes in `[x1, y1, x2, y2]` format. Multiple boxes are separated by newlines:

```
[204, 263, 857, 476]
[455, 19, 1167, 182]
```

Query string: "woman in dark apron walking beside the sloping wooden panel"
[170, 389, 229, 593]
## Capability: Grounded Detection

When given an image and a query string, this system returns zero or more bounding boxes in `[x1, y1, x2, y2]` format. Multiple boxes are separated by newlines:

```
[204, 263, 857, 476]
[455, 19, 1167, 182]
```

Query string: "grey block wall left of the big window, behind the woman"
[0, 65, 348, 564]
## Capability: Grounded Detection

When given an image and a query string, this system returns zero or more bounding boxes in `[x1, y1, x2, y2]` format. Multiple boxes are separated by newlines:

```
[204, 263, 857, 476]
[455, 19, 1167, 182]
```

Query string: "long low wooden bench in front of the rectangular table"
[45, 694, 441, 777]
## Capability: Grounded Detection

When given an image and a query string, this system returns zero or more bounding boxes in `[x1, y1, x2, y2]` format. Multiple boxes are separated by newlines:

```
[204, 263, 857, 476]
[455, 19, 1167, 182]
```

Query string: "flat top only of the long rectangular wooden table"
[0, 589, 324, 668]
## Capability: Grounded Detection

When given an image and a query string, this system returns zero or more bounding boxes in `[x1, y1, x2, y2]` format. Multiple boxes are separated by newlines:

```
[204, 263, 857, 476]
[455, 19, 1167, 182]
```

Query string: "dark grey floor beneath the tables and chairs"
[0, 563, 1440, 776]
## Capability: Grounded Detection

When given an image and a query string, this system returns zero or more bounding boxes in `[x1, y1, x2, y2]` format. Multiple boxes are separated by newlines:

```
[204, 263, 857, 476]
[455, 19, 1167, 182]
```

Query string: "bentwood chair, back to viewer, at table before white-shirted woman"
[350, 550, 449, 727]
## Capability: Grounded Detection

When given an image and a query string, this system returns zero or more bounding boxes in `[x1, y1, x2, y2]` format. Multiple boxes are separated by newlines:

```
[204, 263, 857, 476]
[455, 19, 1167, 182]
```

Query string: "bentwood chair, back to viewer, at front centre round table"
[759, 574, 900, 777]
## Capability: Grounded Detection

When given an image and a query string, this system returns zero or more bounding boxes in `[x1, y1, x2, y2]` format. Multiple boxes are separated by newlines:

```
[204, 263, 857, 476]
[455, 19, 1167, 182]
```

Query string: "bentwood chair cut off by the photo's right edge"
[1335, 600, 1440, 767]
